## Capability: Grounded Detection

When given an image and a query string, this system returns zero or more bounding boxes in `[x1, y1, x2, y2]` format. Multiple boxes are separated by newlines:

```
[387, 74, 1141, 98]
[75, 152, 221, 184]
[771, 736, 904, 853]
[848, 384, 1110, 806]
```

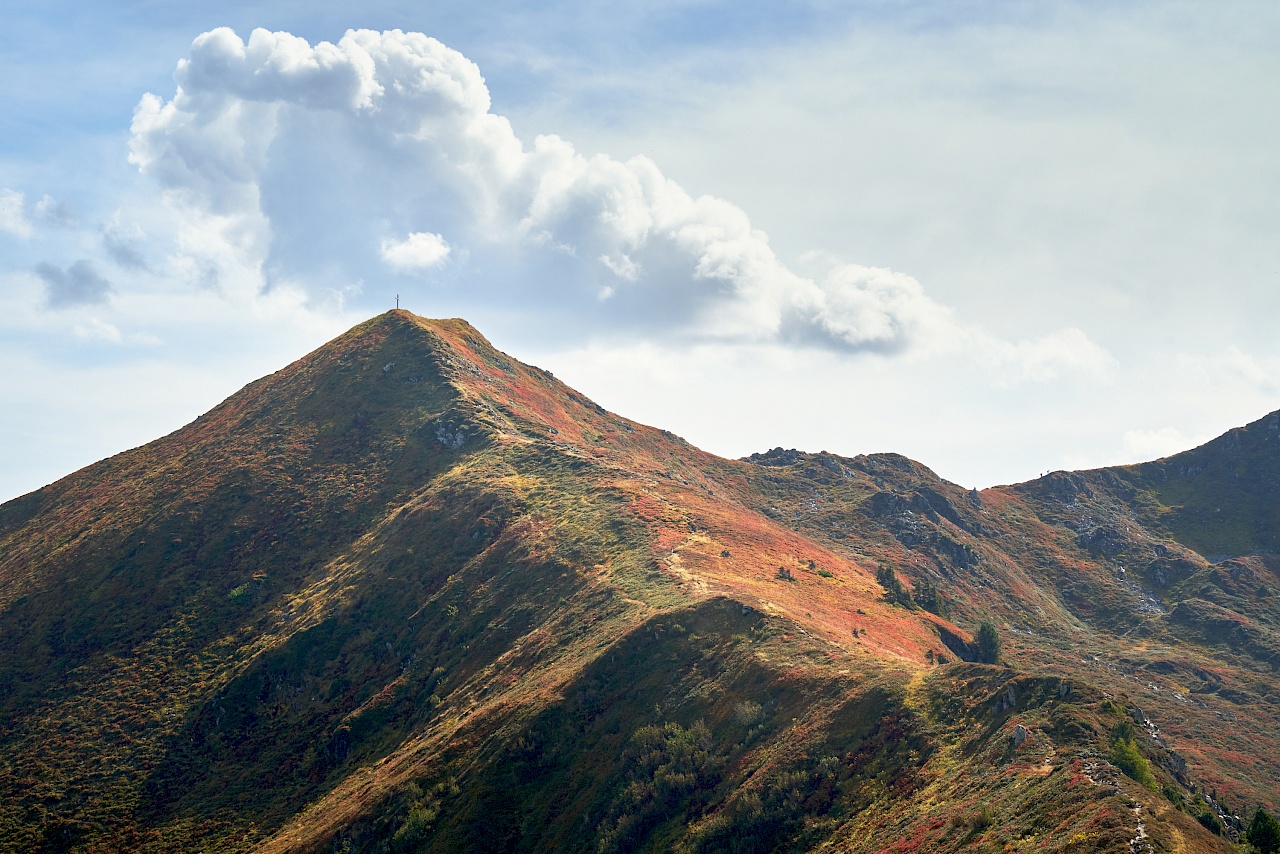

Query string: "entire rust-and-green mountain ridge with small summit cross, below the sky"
[0, 311, 1280, 854]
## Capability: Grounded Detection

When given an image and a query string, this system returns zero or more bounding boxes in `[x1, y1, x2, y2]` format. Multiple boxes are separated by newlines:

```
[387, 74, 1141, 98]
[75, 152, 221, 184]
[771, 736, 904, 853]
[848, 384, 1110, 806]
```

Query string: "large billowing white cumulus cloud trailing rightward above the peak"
[131, 28, 1097, 378]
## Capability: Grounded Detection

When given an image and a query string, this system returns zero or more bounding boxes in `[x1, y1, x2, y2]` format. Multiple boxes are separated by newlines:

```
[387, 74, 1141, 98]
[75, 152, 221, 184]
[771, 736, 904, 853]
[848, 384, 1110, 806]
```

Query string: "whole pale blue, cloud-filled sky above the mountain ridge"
[0, 0, 1280, 501]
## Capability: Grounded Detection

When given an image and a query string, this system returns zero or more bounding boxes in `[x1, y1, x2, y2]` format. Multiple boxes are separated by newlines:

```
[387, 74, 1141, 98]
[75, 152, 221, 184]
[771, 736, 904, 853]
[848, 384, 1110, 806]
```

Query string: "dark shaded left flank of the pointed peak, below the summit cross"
[0, 313, 483, 846]
